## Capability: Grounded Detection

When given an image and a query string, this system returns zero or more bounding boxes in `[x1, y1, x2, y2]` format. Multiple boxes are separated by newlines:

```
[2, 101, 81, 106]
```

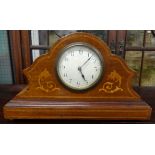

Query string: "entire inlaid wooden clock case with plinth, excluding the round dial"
[4, 33, 151, 120]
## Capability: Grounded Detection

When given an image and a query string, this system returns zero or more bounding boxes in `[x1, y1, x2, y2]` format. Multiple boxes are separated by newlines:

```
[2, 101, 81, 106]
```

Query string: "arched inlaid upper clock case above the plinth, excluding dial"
[15, 33, 140, 101]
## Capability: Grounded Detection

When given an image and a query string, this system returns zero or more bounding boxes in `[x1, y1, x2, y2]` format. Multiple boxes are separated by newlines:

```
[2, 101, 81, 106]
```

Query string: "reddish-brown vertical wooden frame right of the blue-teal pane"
[9, 30, 31, 84]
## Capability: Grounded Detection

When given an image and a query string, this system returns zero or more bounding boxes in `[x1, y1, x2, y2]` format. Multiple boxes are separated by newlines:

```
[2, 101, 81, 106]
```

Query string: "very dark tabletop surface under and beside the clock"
[0, 85, 155, 124]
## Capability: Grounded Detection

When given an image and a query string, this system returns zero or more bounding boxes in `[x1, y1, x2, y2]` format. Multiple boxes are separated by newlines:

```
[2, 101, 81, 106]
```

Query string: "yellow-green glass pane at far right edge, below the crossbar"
[142, 51, 155, 86]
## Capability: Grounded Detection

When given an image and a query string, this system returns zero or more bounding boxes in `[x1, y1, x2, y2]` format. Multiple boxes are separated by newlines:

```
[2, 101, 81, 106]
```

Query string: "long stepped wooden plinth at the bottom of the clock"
[3, 100, 152, 120]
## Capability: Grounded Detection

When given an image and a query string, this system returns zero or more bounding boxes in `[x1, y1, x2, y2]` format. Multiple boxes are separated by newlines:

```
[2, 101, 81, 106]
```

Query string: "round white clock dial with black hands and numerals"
[57, 43, 103, 90]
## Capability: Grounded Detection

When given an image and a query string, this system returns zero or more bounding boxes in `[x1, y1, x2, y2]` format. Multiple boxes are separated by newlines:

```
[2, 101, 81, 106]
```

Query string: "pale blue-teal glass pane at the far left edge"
[0, 30, 13, 84]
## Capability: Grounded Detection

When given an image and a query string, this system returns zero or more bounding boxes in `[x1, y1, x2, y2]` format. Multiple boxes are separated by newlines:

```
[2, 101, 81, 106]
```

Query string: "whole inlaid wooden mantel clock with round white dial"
[4, 33, 151, 120]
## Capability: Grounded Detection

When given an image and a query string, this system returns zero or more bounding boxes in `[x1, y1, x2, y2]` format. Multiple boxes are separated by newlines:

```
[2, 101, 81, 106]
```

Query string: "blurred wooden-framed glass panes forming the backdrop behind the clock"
[0, 30, 155, 87]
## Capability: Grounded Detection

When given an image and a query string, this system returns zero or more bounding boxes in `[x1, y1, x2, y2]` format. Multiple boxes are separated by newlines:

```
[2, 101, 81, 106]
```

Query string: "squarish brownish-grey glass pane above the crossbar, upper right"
[126, 30, 144, 47]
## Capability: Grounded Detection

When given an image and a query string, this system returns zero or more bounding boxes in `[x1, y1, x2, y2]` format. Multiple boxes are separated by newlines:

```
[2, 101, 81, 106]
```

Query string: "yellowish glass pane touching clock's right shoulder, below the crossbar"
[125, 51, 142, 86]
